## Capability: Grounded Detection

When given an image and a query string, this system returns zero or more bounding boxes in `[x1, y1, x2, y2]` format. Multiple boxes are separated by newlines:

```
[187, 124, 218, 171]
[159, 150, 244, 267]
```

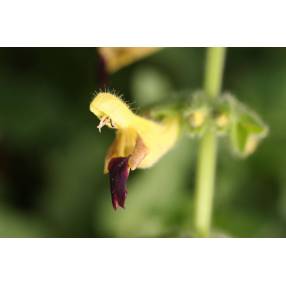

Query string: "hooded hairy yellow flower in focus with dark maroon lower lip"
[90, 92, 179, 209]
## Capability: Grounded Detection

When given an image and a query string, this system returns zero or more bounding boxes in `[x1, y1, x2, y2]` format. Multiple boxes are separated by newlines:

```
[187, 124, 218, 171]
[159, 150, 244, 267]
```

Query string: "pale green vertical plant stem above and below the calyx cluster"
[194, 48, 225, 237]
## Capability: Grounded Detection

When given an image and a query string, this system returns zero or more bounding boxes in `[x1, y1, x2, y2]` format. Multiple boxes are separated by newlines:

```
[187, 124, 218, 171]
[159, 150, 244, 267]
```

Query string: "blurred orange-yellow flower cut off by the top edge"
[98, 47, 160, 73]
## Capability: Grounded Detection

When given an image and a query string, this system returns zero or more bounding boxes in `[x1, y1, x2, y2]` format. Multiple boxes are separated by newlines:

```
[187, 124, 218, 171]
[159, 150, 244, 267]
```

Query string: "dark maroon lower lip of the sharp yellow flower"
[108, 157, 129, 210]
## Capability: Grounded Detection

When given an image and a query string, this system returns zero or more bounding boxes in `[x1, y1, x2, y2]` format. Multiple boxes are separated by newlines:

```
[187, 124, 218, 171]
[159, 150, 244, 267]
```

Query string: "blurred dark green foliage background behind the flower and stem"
[0, 48, 286, 237]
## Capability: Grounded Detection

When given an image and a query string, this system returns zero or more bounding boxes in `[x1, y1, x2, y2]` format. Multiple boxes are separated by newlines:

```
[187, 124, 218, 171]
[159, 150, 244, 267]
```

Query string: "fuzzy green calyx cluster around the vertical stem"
[183, 92, 268, 157]
